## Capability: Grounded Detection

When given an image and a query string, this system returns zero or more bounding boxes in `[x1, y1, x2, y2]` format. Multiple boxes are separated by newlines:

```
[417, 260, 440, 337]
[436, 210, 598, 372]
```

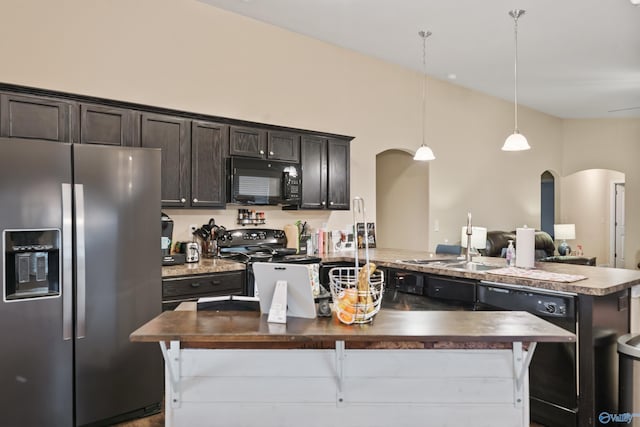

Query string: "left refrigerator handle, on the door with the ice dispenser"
[62, 184, 73, 341]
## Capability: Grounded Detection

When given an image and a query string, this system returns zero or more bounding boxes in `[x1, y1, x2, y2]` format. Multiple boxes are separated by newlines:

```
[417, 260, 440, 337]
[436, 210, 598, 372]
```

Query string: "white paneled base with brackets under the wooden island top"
[165, 342, 529, 427]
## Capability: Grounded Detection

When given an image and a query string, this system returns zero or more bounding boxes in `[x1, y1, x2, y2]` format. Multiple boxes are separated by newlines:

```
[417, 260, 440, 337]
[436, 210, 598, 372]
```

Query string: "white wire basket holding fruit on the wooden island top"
[329, 263, 384, 325]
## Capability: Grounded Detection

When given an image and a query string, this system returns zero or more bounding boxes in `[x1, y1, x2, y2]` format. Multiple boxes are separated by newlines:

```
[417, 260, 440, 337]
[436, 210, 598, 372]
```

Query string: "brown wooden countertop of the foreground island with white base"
[130, 309, 575, 347]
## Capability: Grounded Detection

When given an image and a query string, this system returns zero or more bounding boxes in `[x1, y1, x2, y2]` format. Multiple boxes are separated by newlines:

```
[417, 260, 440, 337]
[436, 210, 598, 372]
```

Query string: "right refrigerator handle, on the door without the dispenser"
[74, 184, 86, 339]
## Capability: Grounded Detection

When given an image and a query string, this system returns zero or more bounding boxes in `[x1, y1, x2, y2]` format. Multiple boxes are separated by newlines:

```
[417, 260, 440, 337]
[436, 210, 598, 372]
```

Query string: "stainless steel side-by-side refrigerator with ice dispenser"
[0, 138, 163, 427]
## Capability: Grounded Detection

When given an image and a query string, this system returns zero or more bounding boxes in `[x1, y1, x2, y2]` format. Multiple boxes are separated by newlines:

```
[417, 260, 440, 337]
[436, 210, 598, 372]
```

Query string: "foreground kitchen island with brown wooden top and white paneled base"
[131, 310, 575, 426]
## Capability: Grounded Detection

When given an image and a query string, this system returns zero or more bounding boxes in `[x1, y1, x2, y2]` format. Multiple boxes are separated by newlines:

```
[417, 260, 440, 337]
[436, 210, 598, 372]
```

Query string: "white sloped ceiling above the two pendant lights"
[199, 0, 640, 118]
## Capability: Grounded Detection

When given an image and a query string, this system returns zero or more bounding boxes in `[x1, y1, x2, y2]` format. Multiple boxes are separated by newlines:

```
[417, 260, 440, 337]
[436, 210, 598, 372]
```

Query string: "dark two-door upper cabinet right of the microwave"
[300, 135, 350, 210]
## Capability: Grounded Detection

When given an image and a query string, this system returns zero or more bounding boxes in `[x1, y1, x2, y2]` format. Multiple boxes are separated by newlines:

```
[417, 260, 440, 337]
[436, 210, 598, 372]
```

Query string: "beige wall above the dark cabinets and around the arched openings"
[0, 0, 640, 262]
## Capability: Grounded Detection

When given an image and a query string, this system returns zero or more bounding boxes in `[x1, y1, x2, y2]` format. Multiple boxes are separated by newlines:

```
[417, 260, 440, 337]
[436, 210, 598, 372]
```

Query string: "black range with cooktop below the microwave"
[218, 228, 321, 296]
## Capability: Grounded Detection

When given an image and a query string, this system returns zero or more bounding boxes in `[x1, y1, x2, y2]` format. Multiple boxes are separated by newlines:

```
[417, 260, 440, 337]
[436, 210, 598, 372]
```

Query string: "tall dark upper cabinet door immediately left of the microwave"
[191, 121, 229, 207]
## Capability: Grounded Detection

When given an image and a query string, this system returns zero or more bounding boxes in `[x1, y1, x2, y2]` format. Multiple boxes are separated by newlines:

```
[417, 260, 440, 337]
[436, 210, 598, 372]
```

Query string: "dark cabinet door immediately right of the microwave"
[300, 136, 327, 209]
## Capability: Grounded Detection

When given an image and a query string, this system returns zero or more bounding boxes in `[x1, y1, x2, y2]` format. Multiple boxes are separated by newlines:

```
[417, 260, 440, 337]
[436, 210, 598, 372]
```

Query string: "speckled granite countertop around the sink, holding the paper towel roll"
[322, 248, 640, 296]
